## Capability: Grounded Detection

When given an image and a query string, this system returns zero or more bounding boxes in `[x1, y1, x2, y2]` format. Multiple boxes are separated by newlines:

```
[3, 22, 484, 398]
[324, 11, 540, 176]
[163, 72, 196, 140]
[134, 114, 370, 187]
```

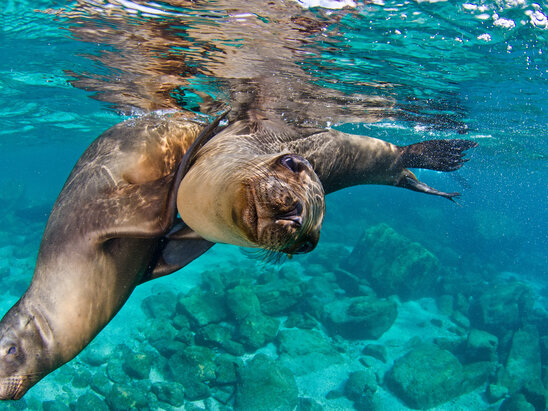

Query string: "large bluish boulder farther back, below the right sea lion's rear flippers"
[343, 224, 441, 300]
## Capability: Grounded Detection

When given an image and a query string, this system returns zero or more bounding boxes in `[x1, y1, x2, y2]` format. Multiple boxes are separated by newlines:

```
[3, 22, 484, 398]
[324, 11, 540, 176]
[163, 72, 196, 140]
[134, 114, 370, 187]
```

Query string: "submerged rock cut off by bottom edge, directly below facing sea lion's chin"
[234, 354, 299, 411]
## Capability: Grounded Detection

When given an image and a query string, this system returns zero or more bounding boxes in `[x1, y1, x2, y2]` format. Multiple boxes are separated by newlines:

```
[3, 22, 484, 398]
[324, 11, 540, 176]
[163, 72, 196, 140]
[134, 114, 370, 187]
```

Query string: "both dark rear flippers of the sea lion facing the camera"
[397, 139, 478, 201]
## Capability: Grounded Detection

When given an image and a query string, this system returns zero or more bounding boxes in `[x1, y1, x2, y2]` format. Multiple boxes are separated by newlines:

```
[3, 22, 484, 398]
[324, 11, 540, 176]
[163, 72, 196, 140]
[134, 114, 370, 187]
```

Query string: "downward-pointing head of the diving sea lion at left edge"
[0, 304, 56, 400]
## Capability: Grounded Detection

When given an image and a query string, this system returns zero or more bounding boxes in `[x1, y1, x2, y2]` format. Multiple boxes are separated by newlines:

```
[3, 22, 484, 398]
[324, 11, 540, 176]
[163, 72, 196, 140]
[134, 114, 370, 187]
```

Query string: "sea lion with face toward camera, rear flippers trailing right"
[177, 113, 476, 254]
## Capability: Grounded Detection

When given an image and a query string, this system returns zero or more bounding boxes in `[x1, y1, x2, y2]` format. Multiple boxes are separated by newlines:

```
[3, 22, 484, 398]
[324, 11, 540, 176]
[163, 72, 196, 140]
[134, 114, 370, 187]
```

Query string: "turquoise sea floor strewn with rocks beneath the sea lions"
[0, 192, 548, 410]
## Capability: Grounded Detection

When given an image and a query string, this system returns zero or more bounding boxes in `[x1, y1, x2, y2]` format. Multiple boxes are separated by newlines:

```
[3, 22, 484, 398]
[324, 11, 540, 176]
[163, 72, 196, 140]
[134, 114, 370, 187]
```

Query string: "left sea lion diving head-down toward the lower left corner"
[0, 113, 229, 399]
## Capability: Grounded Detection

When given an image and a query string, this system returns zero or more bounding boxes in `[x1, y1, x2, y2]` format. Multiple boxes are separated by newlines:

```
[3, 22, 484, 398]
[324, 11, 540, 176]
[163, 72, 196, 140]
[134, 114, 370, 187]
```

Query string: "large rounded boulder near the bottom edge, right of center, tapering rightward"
[385, 345, 493, 409]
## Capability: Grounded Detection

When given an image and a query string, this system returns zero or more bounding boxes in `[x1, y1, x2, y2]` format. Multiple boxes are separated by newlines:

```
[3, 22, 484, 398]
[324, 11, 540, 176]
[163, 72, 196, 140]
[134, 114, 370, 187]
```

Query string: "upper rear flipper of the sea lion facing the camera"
[399, 139, 478, 171]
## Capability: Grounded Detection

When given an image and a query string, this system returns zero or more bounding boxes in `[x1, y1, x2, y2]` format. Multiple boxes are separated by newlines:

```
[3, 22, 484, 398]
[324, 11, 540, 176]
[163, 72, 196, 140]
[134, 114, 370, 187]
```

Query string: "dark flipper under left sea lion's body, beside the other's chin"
[141, 220, 215, 284]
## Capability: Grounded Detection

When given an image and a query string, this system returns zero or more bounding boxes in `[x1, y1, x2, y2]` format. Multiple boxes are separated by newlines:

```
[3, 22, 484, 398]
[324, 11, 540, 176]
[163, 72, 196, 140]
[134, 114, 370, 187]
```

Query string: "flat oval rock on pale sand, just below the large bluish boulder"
[324, 296, 398, 340]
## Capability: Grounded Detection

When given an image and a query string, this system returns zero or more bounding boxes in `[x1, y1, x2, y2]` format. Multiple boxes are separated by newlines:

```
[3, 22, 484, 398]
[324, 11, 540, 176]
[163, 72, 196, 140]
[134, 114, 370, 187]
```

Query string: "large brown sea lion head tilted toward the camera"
[177, 153, 325, 255]
